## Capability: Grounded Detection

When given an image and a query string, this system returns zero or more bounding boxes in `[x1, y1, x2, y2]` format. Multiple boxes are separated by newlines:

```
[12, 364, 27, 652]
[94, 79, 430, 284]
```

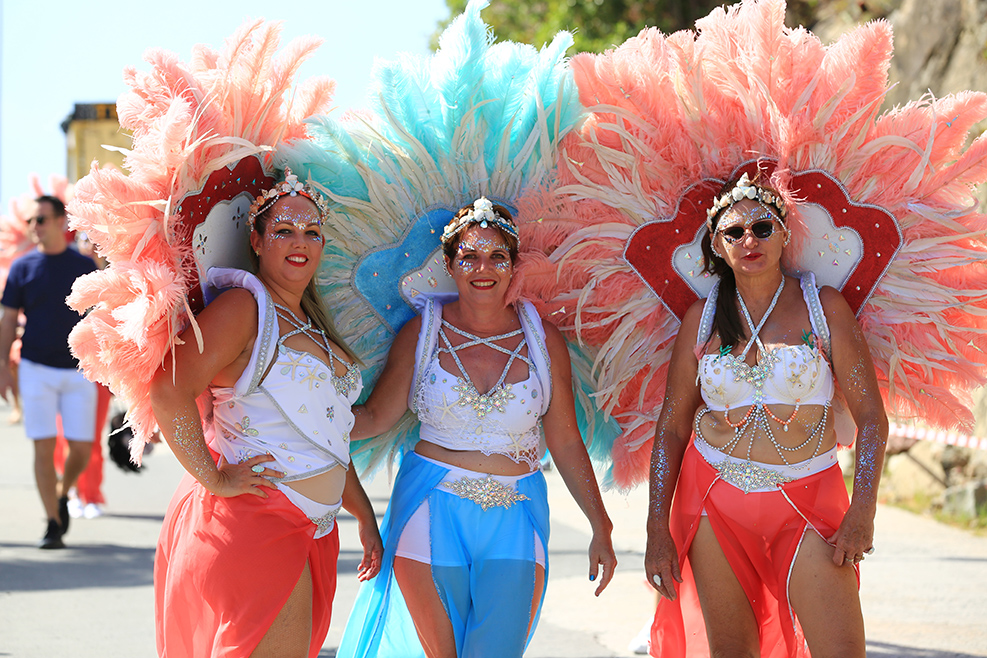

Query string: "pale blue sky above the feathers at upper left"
[0, 0, 449, 214]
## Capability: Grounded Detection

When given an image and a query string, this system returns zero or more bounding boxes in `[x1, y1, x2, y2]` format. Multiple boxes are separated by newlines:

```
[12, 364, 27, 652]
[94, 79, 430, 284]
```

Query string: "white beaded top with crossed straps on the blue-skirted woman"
[415, 320, 545, 470]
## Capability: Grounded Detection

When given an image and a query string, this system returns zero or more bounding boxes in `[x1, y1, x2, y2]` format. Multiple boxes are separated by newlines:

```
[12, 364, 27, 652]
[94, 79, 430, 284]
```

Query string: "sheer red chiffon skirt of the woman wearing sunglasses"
[651, 443, 849, 658]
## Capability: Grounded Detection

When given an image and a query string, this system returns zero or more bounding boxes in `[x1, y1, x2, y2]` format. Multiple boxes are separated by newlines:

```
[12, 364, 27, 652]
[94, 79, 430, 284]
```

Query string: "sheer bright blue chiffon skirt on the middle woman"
[336, 452, 548, 658]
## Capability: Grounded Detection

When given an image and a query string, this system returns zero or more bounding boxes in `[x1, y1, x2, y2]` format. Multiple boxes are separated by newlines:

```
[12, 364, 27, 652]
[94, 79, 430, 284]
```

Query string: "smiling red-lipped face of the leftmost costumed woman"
[250, 196, 325, 287]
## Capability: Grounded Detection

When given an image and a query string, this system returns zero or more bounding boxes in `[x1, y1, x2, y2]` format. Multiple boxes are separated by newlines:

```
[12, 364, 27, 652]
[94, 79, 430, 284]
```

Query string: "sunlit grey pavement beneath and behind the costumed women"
[0, 404, 987, 658]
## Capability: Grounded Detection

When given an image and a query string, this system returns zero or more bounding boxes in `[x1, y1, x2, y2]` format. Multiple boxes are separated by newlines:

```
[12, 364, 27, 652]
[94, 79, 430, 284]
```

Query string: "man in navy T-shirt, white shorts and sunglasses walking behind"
[0, 196, 96, 548]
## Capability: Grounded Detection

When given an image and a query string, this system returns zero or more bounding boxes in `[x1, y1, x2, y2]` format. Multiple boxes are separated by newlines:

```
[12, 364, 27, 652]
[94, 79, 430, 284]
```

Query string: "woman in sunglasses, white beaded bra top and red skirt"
[645, 174, 888, 658]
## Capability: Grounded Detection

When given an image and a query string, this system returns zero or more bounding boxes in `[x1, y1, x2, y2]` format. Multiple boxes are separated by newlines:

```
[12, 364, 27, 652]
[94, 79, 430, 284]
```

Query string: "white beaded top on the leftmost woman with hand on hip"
[209, 268, 363, 482]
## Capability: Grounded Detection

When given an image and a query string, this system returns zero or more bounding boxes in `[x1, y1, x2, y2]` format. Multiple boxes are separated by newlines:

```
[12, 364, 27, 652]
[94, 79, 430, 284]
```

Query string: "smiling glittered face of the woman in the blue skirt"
[446, 225, 514, 297]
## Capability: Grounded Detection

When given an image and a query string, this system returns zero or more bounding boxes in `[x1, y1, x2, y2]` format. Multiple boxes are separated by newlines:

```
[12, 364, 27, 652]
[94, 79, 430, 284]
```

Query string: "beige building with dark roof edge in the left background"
[62, 103, 131, 183]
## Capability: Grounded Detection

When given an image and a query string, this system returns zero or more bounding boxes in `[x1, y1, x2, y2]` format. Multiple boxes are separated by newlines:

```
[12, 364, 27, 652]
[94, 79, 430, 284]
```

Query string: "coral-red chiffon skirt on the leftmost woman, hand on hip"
[154, 475, 339, 658]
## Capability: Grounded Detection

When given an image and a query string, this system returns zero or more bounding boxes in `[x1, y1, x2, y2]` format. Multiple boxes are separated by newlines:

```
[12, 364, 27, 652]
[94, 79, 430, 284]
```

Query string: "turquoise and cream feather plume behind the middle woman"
[277, 0, 588, 472]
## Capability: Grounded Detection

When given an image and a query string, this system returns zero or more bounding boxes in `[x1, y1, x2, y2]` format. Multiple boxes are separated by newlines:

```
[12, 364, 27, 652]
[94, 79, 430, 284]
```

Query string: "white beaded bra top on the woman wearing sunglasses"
[698, 270, 835, 411]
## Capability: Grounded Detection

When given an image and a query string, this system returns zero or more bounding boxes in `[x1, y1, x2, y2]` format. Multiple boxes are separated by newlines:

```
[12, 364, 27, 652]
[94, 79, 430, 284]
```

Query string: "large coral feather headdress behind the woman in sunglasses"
[521, 0, 987, 487]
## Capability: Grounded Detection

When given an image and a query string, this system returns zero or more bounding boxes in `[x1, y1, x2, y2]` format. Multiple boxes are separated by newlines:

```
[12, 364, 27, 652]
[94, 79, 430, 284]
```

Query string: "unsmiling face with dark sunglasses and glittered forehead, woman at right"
[713, 199, 787, 274]
